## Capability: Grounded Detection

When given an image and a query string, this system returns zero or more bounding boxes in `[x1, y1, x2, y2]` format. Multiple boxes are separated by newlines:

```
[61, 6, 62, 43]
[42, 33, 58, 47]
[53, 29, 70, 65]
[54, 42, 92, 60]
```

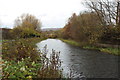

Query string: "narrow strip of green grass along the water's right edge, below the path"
[60, 39, 120, 55]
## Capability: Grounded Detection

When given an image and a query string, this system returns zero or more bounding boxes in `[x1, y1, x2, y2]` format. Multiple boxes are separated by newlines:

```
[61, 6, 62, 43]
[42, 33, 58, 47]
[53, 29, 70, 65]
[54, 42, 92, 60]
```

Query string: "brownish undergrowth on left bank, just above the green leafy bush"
[2, 40, 38, 60]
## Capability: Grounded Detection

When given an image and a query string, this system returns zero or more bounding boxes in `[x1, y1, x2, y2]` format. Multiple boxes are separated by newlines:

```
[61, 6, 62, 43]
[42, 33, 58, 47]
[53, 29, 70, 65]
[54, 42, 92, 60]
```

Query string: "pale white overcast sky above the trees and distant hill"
[0, 0, 85, 28]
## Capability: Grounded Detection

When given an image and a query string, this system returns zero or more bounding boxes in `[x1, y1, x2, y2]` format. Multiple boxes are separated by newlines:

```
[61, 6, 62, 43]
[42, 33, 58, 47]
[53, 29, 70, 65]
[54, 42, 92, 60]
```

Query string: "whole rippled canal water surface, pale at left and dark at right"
[37, 39, 118, 78]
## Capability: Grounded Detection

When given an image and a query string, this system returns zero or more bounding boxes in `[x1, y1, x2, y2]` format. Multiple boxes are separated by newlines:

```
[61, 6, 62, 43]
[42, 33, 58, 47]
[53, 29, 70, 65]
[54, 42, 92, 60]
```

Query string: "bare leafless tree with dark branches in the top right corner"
[85, 0, 120, 26]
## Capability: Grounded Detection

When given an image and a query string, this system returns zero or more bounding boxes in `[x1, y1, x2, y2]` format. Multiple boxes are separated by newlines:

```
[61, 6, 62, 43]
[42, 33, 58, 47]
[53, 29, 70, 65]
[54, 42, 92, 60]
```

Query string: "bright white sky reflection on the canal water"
[37, 39, 71, 76]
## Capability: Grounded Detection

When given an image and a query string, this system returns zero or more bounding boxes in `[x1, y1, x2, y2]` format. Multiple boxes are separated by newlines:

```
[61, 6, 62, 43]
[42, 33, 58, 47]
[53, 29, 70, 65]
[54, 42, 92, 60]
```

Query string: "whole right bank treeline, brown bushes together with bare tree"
[61, 0, 120, 44]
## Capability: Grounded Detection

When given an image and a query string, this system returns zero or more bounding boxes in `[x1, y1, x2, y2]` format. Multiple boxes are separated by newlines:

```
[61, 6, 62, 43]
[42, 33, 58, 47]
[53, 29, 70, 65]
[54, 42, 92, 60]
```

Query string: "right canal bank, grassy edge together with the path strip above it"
[59, 38, 120, 56]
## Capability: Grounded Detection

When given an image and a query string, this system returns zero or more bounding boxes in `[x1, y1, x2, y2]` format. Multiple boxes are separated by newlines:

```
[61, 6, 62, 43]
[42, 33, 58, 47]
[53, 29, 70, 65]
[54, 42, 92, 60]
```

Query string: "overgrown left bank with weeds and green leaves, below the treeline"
[2, 38, 62, 79]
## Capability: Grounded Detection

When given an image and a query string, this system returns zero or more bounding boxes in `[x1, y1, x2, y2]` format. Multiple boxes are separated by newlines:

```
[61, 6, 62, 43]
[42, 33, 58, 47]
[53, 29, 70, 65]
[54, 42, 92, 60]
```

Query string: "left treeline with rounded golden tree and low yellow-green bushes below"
[2, 14, 42, 39]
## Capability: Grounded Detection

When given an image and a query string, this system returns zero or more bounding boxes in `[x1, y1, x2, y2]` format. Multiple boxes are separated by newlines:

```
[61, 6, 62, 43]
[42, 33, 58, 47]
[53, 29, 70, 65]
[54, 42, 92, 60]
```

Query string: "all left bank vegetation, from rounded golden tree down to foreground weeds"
[2, 14, 62, 79]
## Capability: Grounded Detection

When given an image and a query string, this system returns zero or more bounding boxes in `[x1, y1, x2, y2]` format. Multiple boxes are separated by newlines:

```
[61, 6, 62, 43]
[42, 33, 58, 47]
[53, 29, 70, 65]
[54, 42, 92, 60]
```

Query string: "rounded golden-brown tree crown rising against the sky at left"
[15, 14, 41, 30]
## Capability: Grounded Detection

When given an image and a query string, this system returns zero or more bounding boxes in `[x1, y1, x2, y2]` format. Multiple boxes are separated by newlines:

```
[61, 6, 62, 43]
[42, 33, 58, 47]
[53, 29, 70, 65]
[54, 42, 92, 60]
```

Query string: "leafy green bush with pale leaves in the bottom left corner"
[3, 57, 41, 79]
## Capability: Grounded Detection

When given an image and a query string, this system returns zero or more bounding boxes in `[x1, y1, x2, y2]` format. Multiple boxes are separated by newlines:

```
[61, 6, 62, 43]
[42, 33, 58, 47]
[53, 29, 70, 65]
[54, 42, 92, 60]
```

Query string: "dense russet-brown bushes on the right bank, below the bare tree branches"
[62, 12, 120, 44]
